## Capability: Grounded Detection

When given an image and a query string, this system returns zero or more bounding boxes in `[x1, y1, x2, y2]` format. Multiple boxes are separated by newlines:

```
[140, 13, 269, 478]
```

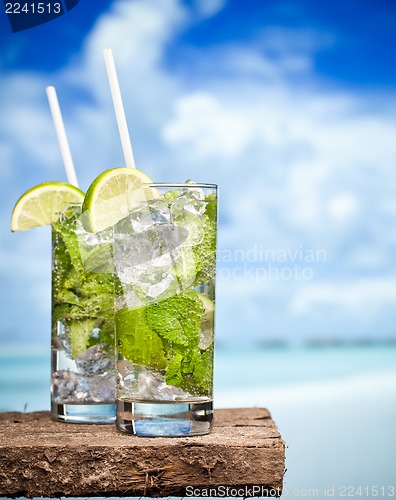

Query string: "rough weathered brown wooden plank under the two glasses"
[0, 408, 285, 498]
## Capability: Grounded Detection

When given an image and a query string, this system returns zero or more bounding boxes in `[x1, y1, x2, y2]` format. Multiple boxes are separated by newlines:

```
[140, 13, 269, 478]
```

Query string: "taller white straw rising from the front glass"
[103, 49, 136, 168]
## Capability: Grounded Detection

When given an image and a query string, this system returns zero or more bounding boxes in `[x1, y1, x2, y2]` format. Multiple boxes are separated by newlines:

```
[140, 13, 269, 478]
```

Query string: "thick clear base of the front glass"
[116, 399, 213, 437]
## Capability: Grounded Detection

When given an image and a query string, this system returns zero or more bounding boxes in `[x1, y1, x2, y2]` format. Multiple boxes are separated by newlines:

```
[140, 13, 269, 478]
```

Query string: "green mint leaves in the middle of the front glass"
[115, 291, 213, 395]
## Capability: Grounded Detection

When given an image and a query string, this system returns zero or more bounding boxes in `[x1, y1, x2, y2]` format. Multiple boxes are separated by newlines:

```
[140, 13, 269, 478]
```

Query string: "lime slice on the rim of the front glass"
[83, 167, 159, 233]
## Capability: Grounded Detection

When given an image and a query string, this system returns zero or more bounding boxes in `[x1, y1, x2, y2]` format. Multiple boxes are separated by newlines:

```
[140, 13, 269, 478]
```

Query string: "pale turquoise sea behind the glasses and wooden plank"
[0, 344, 396, 499]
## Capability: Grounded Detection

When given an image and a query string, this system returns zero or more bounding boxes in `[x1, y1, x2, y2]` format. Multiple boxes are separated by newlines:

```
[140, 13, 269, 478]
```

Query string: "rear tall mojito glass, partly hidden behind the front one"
[51, 207, 115, 423]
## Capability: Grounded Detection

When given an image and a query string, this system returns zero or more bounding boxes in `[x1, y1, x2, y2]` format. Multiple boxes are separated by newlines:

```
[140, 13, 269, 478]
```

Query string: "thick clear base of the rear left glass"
[51, 402, 116, 424]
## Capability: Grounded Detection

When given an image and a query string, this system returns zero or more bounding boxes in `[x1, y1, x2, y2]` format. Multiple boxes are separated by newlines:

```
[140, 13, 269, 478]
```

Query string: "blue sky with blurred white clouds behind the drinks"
[0, 0, 396, 343]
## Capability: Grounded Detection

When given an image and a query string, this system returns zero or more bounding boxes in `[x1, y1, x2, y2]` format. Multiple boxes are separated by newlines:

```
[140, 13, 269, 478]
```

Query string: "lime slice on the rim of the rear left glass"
[11, 182, 84, 231]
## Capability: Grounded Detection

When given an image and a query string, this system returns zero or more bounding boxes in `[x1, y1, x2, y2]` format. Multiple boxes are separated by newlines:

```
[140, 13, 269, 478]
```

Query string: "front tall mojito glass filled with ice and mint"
[114, 182, 217, 436]
